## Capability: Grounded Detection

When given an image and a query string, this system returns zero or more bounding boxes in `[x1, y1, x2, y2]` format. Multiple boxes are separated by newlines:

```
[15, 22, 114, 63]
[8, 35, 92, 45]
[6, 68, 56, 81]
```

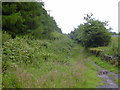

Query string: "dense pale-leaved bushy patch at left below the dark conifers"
[2, 38, 52, 65]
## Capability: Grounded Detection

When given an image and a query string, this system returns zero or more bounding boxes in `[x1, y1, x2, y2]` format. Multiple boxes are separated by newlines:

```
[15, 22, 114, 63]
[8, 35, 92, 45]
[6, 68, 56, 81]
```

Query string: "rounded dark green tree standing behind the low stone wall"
[71, 14, 111, 47]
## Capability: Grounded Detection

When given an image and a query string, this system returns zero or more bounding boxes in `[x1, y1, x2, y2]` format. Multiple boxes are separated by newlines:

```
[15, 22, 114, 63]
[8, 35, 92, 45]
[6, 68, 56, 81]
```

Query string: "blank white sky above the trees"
[42, 0, 120, 34]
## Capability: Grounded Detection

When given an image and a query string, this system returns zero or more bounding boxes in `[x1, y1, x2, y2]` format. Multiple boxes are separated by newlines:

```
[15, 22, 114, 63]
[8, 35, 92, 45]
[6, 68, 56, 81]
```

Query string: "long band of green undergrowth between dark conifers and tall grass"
[2, 32, 72, 66]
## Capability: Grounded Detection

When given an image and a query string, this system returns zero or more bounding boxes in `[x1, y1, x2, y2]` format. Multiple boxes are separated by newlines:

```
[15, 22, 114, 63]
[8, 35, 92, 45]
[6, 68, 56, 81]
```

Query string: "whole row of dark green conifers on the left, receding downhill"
[2, 2, 61, 38]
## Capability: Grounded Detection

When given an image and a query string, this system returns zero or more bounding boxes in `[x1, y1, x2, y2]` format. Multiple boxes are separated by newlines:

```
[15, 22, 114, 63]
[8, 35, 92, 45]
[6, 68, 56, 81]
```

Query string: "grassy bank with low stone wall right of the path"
[88, 37, 120, 67]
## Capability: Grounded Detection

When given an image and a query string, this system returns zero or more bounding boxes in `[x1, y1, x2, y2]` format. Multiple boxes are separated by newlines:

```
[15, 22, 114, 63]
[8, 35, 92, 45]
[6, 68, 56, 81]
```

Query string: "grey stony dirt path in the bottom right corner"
[91, 61, 118, 88]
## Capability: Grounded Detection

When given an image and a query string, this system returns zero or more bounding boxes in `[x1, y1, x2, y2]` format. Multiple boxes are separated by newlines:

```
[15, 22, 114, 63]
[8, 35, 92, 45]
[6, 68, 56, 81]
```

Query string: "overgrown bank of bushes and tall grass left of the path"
[2, 34, 101, 88]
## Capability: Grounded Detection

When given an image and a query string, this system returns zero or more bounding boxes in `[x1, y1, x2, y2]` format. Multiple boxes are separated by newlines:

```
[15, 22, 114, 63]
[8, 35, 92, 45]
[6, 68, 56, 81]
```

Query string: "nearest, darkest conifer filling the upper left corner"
[2, 2, 41, 34]
